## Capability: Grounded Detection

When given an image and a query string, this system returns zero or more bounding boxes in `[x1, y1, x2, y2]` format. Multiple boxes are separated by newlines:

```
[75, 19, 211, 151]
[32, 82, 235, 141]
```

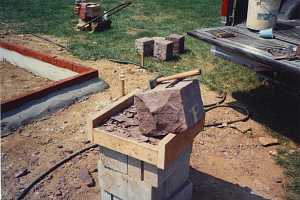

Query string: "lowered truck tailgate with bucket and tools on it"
[188, 25, 300, 77]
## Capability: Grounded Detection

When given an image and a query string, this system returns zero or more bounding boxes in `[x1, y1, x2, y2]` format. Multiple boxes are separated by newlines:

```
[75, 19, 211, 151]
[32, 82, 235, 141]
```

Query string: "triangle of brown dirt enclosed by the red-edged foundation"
[0, 61, 52, 102]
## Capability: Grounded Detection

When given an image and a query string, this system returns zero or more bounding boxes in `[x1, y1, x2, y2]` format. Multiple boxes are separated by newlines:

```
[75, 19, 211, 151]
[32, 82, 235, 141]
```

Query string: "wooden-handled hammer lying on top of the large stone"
[149, 69, 201, 89]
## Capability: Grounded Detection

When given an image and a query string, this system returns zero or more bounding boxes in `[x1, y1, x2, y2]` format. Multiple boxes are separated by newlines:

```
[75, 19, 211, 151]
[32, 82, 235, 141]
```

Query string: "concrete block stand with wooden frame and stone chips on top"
[89, 86, 205, 200]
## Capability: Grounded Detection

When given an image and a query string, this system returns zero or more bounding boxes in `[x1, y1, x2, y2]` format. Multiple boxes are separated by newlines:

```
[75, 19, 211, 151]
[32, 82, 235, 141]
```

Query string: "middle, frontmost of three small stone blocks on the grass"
[153, 39, 173, 61]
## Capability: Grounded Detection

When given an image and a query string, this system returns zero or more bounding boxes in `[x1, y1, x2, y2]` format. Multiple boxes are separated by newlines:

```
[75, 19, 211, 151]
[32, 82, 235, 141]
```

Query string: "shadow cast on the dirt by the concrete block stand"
[190, 168, 265, 200]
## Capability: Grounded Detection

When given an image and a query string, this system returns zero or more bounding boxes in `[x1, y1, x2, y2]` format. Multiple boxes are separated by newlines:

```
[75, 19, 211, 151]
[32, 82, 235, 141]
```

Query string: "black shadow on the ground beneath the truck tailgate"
[232, 86, 300, 144]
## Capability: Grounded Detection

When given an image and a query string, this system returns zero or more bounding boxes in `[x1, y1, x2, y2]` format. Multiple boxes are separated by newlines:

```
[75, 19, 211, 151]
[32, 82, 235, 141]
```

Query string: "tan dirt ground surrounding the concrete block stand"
[1, 35, 286, 200]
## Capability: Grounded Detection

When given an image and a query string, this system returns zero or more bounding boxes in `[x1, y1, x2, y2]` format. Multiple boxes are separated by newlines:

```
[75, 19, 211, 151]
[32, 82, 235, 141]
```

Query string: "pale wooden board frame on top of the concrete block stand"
[88, 91, 205, 169]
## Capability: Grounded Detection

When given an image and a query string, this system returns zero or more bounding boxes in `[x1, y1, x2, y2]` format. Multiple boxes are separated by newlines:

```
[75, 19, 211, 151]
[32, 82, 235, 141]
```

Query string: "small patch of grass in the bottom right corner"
[276, 149, 300, 200]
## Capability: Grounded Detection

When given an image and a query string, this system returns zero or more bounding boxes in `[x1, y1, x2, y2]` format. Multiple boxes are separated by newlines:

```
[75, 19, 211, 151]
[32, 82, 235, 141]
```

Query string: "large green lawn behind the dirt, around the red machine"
[0, 0, 258, 91]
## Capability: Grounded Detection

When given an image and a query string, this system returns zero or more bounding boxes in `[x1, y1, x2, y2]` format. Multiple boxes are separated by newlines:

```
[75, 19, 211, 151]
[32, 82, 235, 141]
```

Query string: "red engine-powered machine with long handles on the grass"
[74, 0, 132, 31]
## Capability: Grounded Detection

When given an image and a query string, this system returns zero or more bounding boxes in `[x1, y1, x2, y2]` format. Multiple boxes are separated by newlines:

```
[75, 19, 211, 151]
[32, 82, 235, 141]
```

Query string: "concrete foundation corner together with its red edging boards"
[0, 41, 108, 137]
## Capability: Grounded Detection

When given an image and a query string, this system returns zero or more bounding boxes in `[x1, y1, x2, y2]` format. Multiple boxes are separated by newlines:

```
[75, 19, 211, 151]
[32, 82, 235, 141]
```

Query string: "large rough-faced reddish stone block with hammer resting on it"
[134, 80, 204, 136]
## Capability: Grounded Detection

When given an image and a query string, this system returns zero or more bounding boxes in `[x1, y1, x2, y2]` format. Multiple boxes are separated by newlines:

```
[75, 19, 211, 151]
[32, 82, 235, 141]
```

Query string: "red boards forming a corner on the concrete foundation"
[0, 41, 98, 113]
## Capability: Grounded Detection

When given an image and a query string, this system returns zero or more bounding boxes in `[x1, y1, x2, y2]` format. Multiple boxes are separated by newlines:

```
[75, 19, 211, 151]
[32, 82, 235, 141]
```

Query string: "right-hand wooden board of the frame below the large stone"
[157, 116, 205, 169]
